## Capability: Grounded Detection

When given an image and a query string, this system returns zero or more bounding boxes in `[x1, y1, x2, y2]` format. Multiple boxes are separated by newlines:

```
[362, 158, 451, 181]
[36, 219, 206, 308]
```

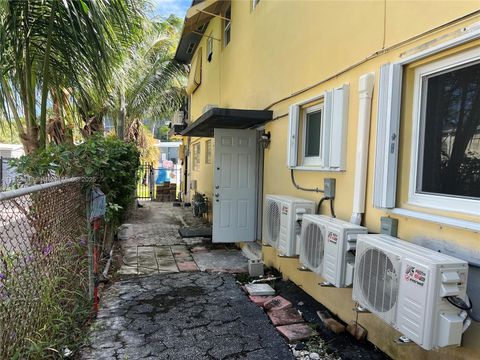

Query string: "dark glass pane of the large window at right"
[417, 63, 480, 198]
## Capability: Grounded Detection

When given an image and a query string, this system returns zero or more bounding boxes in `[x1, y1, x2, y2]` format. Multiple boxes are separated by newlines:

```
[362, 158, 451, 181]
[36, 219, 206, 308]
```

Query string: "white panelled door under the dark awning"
[212, 129, 257, 243]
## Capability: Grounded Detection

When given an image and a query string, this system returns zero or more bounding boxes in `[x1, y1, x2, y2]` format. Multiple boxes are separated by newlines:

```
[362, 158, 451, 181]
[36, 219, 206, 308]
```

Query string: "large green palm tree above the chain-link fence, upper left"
[0, 0, 143, 153]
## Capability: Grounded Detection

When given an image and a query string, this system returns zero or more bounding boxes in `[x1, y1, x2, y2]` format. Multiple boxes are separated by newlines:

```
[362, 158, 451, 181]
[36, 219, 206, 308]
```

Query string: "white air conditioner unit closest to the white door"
[263, 195, 315, 256]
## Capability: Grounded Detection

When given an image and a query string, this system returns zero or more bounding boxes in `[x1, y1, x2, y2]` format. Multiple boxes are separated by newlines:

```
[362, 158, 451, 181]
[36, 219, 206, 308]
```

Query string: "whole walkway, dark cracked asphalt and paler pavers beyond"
[80, 203, 293, 360]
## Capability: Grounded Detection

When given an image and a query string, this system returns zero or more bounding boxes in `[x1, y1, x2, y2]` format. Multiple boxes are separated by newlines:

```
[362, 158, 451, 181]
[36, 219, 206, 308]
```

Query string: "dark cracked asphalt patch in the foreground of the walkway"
[82, 272, 293, 360]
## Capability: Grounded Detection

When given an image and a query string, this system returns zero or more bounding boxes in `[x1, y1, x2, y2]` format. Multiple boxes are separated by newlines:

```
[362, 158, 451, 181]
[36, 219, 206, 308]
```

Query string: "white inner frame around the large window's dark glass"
[408, 48, 480, 214]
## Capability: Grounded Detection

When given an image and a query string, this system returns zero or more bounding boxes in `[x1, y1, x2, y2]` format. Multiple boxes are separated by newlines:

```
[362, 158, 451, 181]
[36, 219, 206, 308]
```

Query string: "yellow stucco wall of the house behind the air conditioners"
[184, 0, 480, 359]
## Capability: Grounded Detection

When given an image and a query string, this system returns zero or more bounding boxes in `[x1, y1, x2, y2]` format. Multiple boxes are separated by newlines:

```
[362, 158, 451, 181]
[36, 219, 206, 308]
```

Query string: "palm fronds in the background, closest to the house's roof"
[113, 15, 186, 138]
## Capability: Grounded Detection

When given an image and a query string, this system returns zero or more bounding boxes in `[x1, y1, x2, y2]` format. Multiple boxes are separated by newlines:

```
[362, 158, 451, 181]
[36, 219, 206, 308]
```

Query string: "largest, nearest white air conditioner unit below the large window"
[353, 235, 468, 350]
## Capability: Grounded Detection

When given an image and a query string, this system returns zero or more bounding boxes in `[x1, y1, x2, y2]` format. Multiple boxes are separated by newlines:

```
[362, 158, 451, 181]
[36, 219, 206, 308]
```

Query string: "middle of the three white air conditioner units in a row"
[300, 215, 368, 287]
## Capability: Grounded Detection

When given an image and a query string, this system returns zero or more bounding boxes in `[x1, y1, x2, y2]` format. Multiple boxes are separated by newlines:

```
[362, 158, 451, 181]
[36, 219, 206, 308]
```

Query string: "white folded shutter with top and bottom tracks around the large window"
[373, 22, 480, 225]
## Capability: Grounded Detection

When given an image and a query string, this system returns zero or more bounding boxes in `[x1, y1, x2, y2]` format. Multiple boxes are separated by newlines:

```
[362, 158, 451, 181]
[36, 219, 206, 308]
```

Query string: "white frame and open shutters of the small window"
[287, 84, 349, 172]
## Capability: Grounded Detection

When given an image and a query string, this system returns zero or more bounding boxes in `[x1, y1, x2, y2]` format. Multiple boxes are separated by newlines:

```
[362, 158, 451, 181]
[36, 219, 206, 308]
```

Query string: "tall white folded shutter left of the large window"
[373, 64, 402, 209]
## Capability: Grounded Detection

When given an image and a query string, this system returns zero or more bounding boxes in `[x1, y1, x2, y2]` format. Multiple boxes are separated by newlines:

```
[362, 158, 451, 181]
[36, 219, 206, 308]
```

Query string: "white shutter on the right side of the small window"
[329, 85, 349, 170]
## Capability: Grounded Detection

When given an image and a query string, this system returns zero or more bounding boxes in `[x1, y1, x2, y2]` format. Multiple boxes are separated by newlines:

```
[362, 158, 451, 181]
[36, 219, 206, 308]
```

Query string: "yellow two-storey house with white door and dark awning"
[176, 0, 480, 359]
